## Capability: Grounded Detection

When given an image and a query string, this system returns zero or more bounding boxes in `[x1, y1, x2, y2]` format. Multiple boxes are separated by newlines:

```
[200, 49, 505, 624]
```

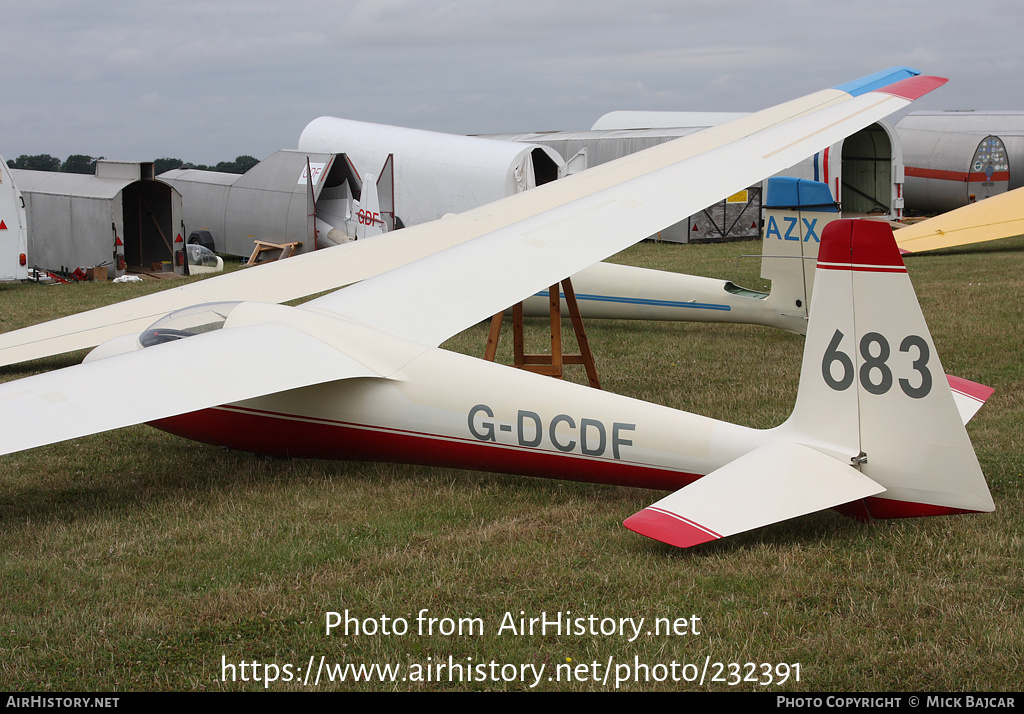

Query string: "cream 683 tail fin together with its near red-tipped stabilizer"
[626, 220, 994, 547]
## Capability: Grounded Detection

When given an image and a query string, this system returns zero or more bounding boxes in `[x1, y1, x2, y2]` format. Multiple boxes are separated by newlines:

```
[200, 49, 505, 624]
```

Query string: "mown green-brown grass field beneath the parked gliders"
[0, 239, 1024, 691]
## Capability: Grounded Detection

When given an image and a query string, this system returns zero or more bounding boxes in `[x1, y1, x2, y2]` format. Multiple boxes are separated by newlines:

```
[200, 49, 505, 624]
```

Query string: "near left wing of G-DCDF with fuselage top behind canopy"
[0, 302, 426, 454]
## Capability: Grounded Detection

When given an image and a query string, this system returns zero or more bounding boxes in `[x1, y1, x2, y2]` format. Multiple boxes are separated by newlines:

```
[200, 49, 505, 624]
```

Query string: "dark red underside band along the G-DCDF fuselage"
[151, 406, 701, 491]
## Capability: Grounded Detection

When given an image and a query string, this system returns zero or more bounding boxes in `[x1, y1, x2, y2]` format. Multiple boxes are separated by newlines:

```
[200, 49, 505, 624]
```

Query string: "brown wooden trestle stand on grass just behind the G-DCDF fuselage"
[483, 278, 601, 389]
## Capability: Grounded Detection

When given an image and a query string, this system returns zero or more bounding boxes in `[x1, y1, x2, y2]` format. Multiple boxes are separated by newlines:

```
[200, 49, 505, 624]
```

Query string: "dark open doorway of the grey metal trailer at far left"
[121, 180, 183, 270]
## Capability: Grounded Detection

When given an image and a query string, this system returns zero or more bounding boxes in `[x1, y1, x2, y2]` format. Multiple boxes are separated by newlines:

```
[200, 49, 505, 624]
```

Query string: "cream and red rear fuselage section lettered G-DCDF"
[153, 349, 766, 490]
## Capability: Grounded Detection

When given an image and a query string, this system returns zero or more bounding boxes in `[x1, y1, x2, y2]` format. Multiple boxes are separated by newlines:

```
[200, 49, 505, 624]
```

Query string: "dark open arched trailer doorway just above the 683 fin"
[842, 124, 895, 215]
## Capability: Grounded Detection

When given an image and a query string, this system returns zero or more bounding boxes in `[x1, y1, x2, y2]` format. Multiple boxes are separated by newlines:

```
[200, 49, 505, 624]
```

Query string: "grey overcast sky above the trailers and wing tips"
[0, 0, 1024, 164]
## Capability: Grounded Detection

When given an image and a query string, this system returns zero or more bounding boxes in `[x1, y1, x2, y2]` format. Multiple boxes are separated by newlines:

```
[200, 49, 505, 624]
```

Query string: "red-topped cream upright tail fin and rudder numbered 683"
[780, 220, 995, 517]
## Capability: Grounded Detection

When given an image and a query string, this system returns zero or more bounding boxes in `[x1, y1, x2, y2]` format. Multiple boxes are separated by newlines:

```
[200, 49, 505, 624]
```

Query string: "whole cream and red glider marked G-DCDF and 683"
[0, 68, 994, 545]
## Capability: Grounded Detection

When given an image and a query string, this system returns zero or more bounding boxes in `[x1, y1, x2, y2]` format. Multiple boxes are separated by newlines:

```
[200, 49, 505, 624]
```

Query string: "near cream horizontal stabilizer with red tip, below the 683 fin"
[623, 442, 885, 548]
